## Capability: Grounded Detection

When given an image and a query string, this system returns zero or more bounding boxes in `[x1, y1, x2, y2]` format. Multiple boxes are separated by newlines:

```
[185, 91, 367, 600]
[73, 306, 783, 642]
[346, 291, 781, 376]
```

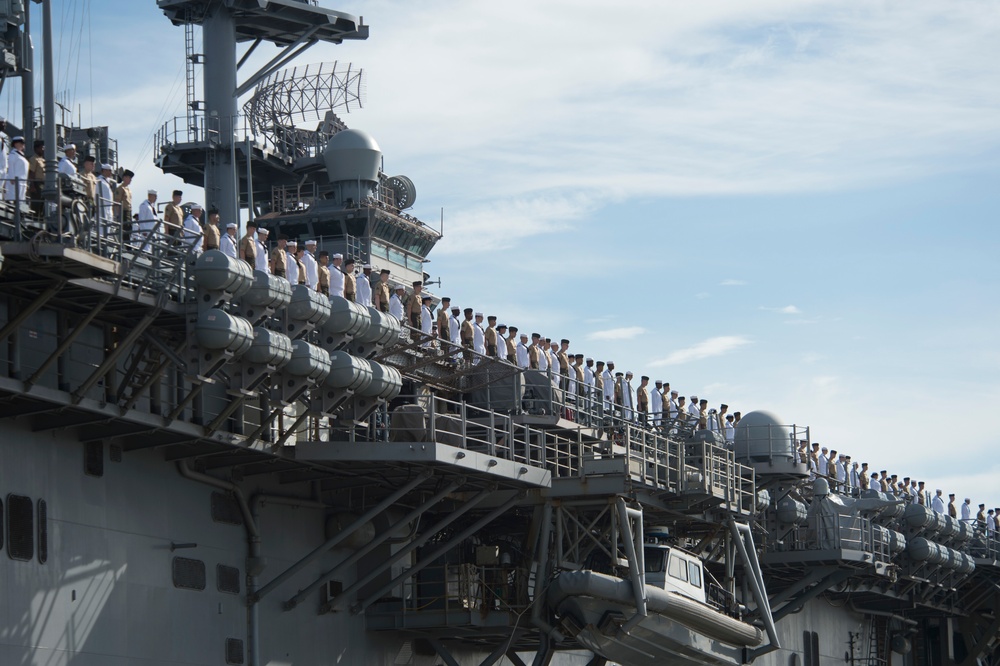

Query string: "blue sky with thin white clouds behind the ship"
[0, 0, 1000, 506]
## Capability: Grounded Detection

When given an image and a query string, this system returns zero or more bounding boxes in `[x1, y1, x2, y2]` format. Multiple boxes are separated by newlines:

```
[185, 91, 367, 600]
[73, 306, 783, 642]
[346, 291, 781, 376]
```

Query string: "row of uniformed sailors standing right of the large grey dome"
[798, 440, 1000, 535]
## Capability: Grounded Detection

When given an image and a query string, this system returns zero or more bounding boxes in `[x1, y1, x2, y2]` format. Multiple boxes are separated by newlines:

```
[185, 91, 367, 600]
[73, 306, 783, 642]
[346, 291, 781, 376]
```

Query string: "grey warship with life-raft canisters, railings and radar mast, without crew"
[0, 0, 1000, 666]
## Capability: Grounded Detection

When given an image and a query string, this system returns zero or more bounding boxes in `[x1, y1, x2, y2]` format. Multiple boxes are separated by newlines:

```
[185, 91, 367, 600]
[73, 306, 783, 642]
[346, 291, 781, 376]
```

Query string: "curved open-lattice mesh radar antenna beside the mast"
[243, 62, 365, 136]
